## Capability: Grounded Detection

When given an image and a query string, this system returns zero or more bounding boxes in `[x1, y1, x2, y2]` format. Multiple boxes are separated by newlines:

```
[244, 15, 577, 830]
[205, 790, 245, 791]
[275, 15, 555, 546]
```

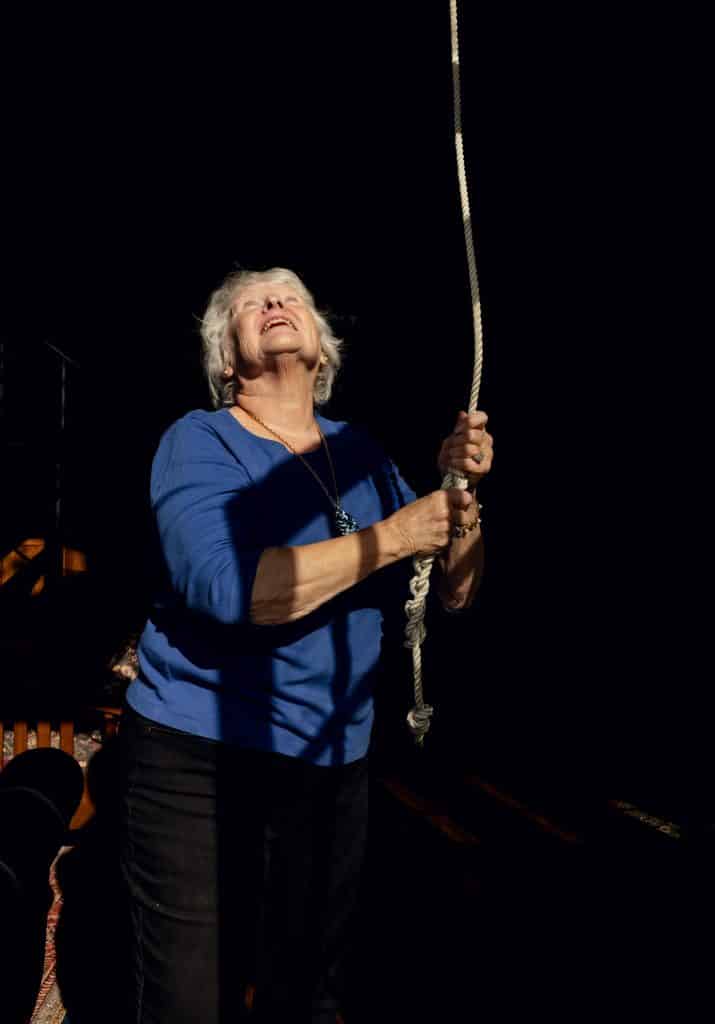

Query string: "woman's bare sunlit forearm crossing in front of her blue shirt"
[250, 519, 410, 626]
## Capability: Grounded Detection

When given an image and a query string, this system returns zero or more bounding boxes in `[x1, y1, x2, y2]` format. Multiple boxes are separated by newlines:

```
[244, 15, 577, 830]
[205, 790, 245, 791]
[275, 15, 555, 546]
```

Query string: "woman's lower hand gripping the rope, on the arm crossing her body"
[385, 487, 474, 557]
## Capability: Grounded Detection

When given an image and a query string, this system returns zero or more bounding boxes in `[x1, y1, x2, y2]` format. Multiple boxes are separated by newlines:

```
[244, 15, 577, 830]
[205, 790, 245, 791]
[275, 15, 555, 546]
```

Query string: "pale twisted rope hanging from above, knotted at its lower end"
[405, 0, 483, 745]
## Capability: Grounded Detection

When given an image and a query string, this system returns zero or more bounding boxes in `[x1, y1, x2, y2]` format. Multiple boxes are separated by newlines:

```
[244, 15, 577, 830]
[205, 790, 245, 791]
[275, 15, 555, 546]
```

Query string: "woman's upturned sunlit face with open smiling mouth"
[230, 283, 321, 377]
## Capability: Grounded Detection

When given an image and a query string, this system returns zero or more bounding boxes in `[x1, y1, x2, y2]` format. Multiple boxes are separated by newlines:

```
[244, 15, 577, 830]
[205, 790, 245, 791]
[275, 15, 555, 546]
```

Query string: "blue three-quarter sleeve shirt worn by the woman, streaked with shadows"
[127, 410, 415, 765]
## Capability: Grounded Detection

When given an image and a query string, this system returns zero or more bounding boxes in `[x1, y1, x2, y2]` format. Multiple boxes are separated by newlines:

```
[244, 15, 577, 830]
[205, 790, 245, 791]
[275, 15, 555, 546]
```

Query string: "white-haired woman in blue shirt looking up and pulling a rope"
[121, 268, 492, 1024]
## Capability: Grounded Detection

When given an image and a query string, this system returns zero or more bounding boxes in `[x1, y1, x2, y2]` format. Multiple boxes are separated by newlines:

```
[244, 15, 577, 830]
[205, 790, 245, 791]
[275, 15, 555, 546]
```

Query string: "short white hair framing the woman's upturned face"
[201, 266, 343, 409]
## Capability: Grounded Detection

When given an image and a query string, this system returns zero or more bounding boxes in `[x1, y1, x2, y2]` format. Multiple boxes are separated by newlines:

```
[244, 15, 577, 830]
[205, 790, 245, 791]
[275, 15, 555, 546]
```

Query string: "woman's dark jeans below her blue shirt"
[120, 709, 368, 1024]
